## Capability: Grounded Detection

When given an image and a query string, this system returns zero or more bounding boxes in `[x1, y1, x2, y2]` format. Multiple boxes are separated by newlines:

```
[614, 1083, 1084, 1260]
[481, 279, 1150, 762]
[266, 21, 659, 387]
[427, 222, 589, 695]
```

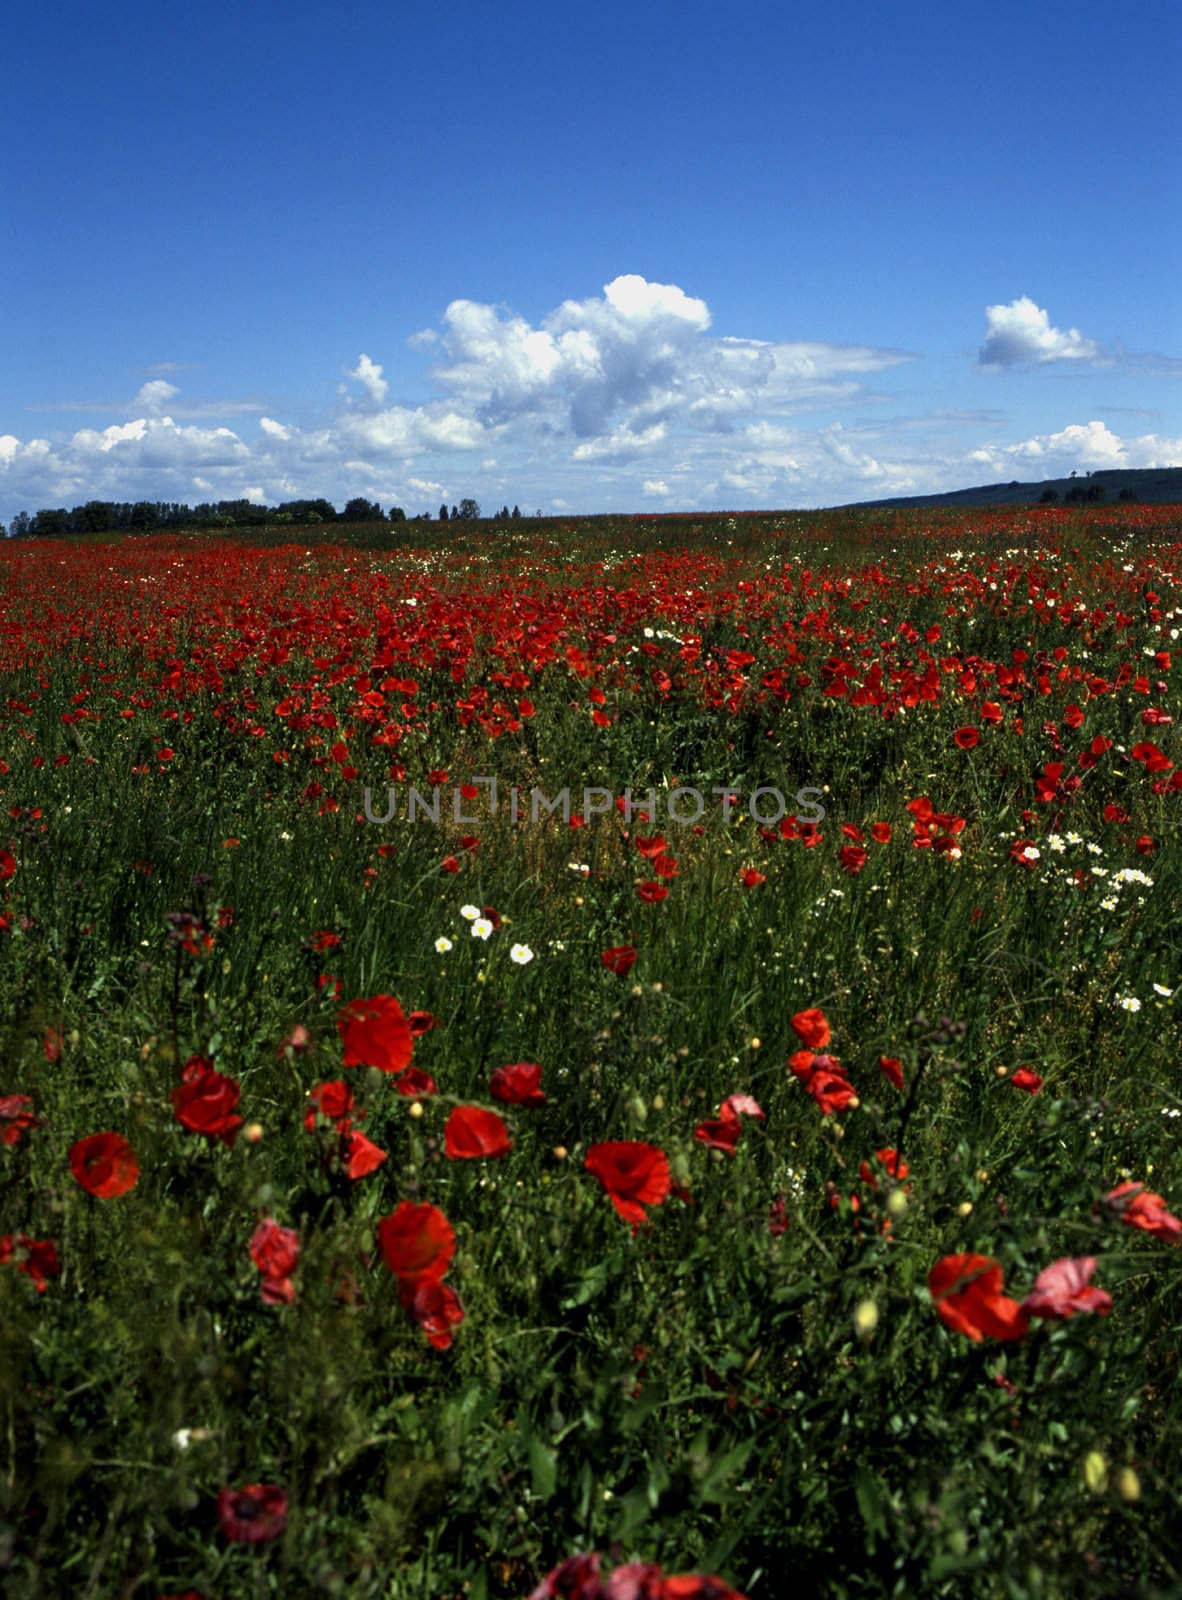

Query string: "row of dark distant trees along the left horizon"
[0, 496, 542, 539]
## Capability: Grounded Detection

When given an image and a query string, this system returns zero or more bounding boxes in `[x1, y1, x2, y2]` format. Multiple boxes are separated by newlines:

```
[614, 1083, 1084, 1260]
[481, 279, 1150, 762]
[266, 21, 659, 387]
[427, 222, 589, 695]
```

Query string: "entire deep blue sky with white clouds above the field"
[0, 0, 1182, 520]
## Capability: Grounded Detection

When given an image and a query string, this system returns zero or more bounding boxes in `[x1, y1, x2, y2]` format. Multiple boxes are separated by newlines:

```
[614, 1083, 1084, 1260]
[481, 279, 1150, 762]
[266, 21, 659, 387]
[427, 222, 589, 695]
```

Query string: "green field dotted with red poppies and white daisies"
[0, 506, 1182, 1600]
